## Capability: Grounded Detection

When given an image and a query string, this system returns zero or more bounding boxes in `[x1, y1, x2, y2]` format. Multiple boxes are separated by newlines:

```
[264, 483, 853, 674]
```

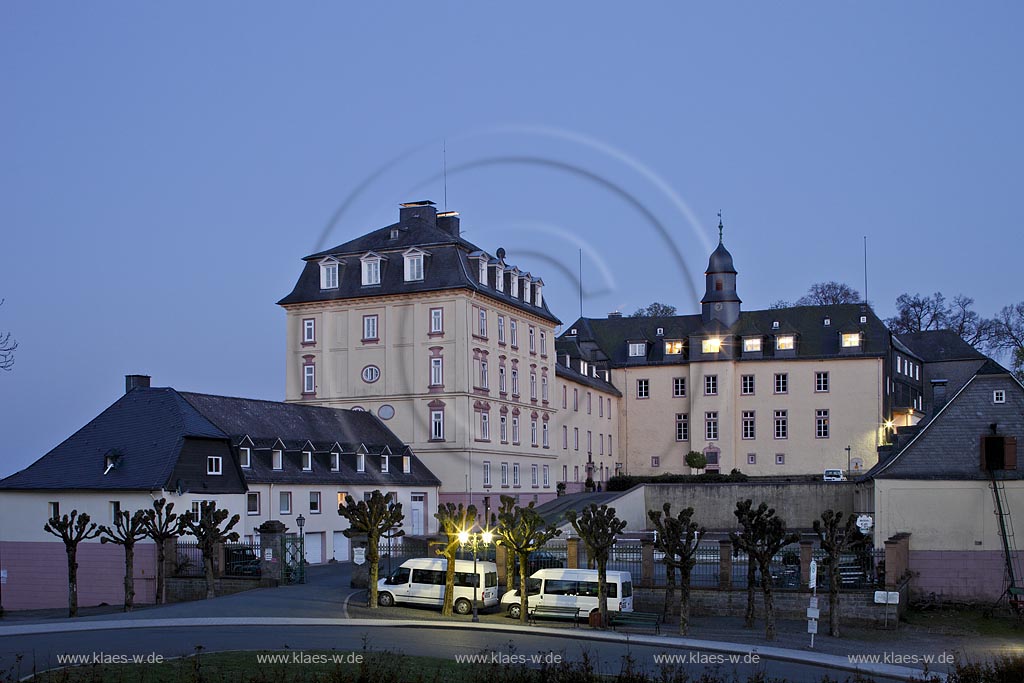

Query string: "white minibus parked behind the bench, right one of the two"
[502, 568, 633, 618]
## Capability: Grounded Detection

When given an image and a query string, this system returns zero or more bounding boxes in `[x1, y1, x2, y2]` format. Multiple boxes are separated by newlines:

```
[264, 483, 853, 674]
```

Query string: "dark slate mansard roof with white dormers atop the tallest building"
[278, 210, 561, 325]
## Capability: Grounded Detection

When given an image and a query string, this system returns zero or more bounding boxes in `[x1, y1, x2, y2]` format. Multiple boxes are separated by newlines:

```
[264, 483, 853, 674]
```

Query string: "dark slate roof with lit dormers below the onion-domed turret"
[559, 304, 890, 367]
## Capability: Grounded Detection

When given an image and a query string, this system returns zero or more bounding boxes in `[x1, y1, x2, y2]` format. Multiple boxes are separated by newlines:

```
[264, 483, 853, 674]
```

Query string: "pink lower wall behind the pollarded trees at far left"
[0, 541, 157, 609]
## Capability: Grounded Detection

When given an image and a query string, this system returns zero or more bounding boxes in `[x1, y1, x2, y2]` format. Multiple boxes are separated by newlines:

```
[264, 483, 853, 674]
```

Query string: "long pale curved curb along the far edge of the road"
[0, 616, 946, 681]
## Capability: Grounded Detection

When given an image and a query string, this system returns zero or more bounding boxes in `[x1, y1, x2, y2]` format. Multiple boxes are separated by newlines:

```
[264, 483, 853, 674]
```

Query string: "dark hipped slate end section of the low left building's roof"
[0, 389, 226, 490]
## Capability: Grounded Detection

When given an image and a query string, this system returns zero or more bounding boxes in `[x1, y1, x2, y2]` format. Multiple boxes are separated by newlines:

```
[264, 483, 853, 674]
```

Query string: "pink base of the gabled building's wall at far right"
[910, 552, 1024, 601]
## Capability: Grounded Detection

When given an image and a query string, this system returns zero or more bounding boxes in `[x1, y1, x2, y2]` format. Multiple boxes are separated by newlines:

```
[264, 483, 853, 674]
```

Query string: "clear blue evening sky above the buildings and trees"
[0, 2, 1024, 476]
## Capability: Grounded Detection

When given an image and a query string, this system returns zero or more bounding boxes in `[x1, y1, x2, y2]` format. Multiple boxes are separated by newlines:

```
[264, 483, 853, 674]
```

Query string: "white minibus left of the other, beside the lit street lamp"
[377, 557, 498, 614]
